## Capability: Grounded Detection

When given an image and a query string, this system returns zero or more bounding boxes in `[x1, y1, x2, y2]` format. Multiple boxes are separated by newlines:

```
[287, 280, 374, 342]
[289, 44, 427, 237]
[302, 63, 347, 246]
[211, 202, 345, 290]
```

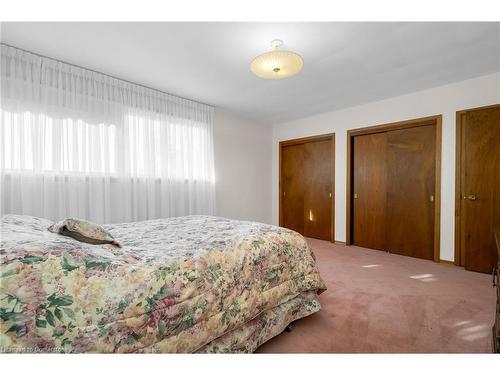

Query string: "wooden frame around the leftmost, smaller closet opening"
[278, 133, 335, 242]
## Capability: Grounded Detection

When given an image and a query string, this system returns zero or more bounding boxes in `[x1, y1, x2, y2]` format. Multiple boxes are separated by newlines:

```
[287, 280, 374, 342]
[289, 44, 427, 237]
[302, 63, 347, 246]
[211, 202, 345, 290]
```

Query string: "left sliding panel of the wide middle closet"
[353, 133, 387, 250]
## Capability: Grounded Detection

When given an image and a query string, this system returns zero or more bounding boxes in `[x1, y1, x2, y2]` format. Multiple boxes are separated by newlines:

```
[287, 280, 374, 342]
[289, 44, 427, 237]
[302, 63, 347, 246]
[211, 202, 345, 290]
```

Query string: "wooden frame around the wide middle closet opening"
[346, 115, 443, 262]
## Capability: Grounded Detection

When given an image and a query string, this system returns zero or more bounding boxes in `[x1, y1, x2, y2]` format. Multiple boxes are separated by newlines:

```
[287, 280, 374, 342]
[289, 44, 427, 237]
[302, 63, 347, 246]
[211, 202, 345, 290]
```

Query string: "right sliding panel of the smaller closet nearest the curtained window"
[301, 139, 333, 241]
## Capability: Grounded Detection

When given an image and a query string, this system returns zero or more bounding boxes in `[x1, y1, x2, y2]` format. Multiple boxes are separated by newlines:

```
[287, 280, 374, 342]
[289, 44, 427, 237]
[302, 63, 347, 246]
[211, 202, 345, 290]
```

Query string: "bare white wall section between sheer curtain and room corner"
[214, 108, 272, 223]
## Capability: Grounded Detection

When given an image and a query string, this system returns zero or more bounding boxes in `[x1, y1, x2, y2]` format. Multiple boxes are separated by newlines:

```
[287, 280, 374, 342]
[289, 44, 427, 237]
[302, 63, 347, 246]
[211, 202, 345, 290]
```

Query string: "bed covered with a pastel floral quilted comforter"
[0, 215, 325, 353]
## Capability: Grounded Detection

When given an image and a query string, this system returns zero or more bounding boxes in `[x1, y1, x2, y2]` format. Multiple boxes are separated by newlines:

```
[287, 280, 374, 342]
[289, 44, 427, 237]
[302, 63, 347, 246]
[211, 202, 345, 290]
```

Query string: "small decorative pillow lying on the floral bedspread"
[48, 217, 121, 247]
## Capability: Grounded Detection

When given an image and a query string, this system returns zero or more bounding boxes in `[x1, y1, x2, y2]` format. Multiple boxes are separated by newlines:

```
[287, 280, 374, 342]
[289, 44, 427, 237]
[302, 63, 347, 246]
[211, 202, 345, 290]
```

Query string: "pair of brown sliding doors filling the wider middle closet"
[352, 125, 436, 259]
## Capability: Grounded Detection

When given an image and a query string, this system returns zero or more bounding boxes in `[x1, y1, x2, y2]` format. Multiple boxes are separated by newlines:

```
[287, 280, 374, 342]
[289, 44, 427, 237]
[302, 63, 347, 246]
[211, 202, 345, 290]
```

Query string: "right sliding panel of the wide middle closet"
[386, 125, 436, 259]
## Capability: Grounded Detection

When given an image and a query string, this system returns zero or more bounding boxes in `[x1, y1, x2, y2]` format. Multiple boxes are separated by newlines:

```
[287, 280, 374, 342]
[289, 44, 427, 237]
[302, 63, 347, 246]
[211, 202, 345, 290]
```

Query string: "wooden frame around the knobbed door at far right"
[454, 104, 500, 266]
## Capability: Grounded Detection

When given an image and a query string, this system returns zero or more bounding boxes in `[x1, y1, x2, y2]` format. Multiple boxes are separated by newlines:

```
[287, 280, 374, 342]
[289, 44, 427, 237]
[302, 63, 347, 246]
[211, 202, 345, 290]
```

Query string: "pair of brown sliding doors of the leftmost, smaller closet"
[280, 136, 334, 241]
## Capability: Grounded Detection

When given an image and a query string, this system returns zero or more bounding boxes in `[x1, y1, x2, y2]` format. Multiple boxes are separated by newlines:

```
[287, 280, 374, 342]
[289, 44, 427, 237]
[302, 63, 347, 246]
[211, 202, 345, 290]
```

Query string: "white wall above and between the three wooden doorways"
[272, 73, 500, 260]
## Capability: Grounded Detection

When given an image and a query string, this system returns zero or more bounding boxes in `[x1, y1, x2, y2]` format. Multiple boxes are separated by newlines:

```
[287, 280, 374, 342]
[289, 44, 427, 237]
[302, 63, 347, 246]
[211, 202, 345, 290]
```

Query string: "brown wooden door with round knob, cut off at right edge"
[461, 107, 500, 273]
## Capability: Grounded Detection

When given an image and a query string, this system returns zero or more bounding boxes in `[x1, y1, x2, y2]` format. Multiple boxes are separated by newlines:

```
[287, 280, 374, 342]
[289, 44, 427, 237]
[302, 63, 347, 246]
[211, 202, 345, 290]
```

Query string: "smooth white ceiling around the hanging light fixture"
[0, 22, 500, 124]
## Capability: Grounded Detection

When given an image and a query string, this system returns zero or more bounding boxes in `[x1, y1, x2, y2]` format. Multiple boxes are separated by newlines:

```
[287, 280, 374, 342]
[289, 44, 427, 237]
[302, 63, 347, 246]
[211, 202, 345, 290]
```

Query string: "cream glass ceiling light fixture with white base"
[250, 39, 304, 79]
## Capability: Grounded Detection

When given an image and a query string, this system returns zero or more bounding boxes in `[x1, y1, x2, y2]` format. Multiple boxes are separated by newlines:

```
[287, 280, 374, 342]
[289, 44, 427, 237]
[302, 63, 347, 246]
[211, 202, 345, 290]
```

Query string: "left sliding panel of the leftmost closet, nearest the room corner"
[281, 144, 305, 234]
